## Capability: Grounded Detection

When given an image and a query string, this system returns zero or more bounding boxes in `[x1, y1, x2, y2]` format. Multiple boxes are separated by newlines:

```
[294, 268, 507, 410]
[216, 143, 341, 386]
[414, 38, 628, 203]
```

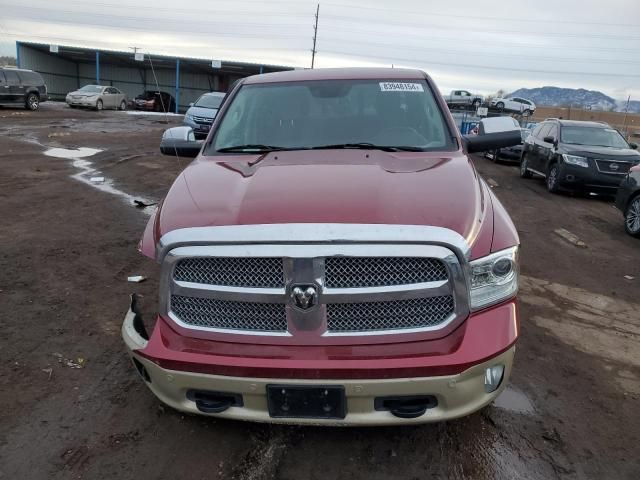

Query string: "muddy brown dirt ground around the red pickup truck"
[0, 103, 640, 480]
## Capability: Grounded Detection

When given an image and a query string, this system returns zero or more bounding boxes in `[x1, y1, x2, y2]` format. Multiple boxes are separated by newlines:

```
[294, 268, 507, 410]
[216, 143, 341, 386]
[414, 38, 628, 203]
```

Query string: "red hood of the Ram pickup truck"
[154, 150, 493, 245]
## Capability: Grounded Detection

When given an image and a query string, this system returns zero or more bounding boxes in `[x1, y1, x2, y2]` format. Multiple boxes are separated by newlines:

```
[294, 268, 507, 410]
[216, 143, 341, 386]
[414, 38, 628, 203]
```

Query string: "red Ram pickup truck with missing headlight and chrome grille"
[122, 69, 520, 425]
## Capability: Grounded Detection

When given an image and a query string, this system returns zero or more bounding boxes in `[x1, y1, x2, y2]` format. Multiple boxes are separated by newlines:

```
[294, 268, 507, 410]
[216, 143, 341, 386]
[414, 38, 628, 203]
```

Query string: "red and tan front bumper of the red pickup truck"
[122, 301, 518, 425]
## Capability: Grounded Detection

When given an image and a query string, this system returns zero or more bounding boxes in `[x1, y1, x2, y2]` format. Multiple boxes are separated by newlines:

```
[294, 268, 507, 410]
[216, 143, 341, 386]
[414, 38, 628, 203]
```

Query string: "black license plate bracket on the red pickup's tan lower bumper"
[267, 385, 347, 419]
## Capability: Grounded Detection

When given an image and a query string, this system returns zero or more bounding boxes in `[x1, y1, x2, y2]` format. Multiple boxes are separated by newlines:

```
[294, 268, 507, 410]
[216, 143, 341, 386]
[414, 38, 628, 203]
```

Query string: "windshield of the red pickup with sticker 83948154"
[207, 80, 457, 155]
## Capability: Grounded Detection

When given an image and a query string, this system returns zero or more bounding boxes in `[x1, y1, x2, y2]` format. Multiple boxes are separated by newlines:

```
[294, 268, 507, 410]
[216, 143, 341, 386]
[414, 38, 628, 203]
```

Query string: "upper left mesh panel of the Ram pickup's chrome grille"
[173, 257, 284, 288]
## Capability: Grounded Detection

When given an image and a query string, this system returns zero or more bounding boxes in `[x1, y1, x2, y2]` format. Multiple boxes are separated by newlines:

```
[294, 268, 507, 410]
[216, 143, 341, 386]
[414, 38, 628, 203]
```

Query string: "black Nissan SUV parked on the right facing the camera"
[520, 118, 640, 195]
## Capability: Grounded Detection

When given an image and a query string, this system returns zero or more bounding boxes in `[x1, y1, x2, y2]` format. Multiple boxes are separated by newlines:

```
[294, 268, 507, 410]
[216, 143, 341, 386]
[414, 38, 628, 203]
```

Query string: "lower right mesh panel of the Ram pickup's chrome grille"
[327, 295, 454, 332]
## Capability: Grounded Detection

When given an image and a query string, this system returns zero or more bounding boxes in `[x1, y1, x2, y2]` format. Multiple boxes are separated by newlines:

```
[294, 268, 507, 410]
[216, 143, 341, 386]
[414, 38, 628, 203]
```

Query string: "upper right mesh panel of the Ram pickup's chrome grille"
[325, 257, 448, 288]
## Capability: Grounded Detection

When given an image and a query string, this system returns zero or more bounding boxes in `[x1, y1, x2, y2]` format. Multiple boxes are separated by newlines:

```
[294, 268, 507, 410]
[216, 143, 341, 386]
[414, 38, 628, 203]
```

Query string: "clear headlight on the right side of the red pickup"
[470, 247, 518, 310]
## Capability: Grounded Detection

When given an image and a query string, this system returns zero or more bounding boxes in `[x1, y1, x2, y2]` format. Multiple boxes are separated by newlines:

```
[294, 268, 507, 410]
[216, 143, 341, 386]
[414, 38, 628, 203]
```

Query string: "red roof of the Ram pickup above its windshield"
[244, 68, 426, 85]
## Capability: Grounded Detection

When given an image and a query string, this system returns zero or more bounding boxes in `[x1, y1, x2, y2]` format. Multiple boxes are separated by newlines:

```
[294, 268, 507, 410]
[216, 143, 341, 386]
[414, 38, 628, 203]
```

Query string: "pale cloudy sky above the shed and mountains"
[0, 0, 640, 100]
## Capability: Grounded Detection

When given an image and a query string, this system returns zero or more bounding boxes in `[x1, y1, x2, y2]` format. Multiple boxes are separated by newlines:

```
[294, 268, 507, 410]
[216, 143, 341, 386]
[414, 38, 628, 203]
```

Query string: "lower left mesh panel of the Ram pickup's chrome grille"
[171, 295, 287, 332]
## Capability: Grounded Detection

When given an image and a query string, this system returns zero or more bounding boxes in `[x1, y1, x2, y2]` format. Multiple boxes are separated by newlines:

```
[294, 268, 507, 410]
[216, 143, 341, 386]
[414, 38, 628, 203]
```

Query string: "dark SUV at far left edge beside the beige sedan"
[0, 68, 47, 110]
